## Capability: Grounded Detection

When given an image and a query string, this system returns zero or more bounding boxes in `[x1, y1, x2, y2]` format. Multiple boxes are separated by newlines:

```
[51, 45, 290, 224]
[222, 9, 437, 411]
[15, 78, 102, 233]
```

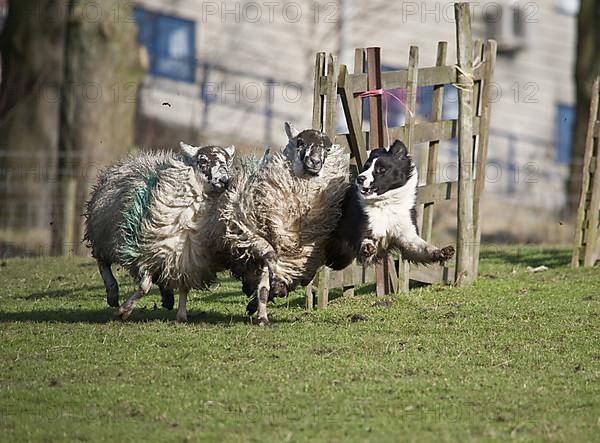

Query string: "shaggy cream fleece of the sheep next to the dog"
[221, 145, 350, 290]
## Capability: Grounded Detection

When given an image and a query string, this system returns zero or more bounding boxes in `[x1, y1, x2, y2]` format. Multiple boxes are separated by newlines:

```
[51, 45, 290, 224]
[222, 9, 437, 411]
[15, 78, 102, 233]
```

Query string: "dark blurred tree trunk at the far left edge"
[0, 0, 65, 239]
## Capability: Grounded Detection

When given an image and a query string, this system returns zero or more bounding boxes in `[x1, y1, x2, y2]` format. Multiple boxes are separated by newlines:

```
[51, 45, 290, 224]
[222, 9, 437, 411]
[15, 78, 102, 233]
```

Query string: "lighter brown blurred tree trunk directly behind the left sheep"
[52, 0, 144, 254]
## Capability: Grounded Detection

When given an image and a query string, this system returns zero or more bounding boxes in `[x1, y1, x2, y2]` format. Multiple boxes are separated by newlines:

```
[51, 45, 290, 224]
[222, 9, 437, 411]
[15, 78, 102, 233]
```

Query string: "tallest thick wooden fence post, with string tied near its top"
[454, 3, 474, 286]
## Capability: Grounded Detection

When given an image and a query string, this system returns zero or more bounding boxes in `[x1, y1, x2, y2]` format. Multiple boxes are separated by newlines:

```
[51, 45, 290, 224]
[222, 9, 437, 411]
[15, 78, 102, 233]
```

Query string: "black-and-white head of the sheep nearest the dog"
[284, 123, 333, 175]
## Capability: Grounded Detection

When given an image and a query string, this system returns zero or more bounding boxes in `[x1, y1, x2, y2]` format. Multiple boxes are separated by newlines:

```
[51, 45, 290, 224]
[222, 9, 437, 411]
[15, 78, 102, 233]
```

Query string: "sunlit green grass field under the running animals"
[0, 247, 600, 442]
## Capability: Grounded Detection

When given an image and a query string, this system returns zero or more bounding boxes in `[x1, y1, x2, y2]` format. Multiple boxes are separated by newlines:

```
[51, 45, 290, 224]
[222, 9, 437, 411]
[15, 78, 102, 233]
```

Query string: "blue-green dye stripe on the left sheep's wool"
[117, 171, 159, 265]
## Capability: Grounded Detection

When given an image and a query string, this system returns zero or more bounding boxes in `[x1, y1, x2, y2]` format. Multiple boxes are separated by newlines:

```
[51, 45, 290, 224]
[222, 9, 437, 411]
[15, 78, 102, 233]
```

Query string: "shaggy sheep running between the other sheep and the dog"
[221, 124, 350, 325]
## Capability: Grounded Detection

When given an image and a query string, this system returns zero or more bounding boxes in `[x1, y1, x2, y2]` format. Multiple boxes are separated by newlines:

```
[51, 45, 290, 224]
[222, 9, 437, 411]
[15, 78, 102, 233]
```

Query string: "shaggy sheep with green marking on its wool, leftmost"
[84, 142, 235, 322]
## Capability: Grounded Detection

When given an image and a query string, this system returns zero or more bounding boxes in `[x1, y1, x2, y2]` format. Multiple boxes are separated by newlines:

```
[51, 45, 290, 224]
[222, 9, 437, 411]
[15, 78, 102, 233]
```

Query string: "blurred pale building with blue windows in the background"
[136, 0, 578, 219]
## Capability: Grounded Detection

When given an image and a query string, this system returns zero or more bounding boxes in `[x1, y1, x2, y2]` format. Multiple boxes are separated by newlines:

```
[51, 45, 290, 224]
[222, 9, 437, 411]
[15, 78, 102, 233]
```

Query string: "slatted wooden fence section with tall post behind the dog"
[306, 3, 496, 309]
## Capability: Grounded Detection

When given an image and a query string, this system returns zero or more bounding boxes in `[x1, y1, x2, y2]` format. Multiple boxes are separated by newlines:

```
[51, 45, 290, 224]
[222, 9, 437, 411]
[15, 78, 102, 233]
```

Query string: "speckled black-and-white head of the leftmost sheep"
[181, 142, 235, 192]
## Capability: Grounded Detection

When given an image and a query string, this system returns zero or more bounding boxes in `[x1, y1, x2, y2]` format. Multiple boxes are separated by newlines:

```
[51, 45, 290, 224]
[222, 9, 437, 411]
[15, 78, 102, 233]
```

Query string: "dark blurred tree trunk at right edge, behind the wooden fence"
[567, 0, 600, 213]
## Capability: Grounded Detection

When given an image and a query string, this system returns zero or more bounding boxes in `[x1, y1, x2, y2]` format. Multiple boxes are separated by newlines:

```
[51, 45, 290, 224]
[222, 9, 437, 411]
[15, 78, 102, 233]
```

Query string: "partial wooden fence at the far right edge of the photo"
[571, 77, 600, 267]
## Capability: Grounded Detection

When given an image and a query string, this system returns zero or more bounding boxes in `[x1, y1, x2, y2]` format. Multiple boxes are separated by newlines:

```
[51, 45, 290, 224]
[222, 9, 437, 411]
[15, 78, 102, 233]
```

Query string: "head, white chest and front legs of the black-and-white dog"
[356, 140, 454, 264]
